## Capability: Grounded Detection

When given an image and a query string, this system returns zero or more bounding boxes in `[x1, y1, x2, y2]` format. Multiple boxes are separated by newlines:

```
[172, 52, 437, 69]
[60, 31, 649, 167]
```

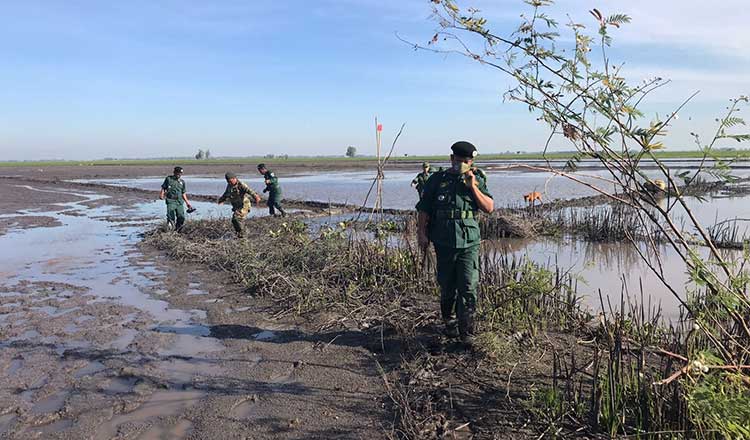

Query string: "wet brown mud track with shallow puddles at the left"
[0, 180, 384, 439]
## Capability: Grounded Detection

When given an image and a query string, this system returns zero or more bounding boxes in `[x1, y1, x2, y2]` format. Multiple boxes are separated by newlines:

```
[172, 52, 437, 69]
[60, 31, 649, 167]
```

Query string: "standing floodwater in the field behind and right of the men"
[73, 166, 750, 319]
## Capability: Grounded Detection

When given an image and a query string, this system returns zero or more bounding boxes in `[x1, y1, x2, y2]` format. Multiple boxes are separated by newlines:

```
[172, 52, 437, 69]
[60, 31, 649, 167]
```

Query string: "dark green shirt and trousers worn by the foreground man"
[417, 169, 492, 334]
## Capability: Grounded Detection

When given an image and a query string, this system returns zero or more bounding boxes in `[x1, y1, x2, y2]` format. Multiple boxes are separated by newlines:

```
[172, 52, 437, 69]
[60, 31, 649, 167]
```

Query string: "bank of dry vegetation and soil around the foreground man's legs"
[140, 218, 743, 438]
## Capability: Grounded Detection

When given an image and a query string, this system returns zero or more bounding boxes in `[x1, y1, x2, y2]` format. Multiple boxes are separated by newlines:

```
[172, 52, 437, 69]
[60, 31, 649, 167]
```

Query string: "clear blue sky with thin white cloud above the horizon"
[0, 0, 750, 159]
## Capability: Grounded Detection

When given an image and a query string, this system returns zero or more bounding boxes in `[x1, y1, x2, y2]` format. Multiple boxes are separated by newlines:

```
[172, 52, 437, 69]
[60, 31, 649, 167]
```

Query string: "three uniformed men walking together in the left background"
[159, 163, 286, 237]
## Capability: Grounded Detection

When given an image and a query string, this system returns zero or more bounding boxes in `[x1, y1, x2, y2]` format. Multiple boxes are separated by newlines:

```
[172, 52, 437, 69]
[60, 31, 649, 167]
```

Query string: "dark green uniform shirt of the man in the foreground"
[417, 168, 492, 249]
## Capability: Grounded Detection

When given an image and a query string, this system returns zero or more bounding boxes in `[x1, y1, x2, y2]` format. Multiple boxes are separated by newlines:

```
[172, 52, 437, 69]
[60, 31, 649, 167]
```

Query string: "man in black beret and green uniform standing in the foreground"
[416, 141, 494, 344]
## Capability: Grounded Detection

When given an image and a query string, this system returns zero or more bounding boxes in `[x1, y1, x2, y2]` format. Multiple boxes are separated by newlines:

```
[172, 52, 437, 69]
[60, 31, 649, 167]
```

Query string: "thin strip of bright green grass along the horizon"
[0, 150, 750, 167]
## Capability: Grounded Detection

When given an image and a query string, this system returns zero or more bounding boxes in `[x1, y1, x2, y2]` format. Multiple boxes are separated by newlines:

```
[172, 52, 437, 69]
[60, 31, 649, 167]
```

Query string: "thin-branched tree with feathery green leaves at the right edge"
[415, 0, 750, 437]
